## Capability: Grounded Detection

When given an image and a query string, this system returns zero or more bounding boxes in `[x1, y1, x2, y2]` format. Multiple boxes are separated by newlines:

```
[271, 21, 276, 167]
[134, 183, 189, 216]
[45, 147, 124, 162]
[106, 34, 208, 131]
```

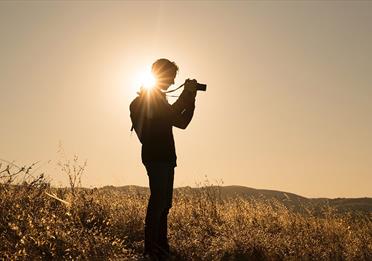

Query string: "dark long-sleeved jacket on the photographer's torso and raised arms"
[129, 86, 196, 166]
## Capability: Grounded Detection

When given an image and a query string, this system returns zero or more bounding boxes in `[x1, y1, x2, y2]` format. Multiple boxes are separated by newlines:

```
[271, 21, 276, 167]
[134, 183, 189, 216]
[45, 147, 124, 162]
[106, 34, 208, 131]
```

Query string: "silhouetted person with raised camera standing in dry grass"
[130, 59, 197, 260]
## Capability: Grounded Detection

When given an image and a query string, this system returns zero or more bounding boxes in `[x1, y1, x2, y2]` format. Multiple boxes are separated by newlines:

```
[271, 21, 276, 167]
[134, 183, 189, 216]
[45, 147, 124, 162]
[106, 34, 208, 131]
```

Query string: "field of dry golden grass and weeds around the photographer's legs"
[0, 160, 372, 260]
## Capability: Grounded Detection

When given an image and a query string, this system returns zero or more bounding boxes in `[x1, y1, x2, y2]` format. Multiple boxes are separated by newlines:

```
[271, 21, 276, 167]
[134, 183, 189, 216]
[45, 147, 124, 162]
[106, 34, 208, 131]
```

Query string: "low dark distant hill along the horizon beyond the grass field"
[101, 185, 372, 213]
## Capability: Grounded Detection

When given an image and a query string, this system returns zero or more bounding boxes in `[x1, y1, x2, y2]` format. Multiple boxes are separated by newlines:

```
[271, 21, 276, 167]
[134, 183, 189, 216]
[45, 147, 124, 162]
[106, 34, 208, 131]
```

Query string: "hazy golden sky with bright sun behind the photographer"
[0, 1, 372, 198]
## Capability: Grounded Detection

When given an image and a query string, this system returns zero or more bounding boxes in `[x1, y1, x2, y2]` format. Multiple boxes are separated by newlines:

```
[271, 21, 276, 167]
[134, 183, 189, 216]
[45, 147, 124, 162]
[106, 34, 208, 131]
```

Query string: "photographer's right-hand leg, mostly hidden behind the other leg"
[159, 166, 174, 253]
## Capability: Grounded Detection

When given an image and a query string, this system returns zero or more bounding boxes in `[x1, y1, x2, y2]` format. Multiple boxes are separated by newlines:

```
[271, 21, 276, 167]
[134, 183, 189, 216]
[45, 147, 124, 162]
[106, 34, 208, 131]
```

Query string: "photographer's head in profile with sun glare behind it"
[151, 58, 178, 90]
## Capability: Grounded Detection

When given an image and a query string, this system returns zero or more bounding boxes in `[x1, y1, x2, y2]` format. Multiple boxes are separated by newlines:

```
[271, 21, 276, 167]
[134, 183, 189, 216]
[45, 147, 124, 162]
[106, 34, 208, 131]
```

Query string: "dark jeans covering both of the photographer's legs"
[145, 163, 174, 254]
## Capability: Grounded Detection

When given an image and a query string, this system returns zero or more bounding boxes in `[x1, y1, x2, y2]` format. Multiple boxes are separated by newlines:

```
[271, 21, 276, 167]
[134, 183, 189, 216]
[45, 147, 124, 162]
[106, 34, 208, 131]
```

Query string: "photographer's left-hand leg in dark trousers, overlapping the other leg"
[145, 164, 169, 253]
